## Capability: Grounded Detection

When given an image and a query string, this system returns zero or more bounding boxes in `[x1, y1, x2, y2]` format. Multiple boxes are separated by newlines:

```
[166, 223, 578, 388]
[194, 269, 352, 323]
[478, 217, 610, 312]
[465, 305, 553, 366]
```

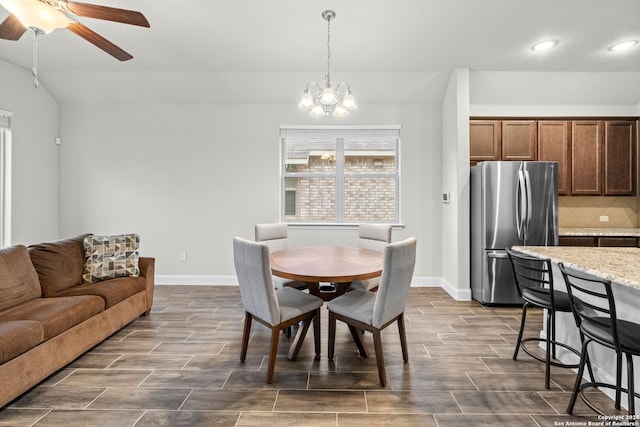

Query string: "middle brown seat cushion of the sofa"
[0, 295, 104, 341]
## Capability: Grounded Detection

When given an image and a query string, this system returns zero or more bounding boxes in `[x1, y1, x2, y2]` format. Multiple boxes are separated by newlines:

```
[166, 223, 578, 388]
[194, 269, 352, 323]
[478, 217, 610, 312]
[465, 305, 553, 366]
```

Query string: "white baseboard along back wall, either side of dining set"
[155, 274, 471, 301]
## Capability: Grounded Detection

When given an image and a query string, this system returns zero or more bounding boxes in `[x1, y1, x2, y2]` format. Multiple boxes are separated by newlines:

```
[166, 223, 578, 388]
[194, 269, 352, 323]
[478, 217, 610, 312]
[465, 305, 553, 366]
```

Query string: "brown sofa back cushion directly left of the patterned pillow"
[29, 234, 89, 297]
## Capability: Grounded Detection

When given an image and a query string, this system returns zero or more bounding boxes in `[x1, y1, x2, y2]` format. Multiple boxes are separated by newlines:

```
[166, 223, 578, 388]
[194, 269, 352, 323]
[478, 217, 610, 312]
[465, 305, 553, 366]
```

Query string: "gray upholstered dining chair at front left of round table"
[233, 237, 322, 384]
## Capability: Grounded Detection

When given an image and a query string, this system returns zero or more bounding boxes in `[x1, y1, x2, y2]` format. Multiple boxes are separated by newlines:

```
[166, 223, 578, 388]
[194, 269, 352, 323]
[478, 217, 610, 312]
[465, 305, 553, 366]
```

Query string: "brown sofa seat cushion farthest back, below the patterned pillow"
[54, 276, 147, 308]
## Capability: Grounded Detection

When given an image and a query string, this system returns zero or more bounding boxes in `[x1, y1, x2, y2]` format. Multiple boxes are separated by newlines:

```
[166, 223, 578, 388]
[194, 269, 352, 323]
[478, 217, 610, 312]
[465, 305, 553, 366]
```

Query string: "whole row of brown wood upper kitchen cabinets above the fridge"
[469, 118, 638, 196]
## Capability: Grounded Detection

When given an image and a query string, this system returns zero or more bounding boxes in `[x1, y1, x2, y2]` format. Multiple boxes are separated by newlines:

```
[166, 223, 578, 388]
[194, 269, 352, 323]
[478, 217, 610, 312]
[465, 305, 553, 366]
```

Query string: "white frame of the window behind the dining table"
[279, 125, 402, 226]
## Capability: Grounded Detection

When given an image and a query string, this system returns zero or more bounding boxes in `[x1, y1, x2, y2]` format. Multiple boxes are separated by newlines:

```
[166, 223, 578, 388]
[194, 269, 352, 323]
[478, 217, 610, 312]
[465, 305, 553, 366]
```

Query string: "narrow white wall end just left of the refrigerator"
[440, 69, 471, 300]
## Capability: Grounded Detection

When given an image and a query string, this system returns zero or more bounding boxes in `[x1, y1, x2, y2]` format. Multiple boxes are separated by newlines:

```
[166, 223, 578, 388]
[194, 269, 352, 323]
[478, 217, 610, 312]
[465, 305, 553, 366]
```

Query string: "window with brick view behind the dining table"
[280, 126, 400, 224]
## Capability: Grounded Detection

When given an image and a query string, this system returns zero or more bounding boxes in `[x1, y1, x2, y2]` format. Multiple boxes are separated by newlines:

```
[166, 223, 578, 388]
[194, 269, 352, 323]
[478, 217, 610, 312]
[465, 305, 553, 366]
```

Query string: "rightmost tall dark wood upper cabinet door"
[604, 120, 637, 196]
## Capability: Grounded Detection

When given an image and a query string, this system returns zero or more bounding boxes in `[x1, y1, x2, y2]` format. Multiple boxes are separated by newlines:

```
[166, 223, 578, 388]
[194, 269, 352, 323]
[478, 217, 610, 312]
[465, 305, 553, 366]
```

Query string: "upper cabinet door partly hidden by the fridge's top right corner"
[538, 120, 571, 196]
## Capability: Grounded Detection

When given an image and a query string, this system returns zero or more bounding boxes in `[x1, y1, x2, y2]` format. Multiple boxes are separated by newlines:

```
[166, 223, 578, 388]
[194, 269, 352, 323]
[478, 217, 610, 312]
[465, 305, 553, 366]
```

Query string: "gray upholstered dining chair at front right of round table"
[327, 237, 416, 387]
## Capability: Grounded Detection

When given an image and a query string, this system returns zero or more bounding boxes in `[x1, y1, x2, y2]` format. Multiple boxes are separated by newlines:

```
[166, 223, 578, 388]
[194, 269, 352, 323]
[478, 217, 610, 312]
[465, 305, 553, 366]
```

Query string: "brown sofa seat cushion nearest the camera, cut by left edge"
[0, 320, 44, 364]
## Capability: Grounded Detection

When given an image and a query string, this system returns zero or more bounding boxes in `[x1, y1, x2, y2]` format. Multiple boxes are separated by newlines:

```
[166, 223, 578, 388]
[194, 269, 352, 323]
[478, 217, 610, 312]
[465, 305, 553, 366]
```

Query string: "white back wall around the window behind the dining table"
[60, 103, 442, 283]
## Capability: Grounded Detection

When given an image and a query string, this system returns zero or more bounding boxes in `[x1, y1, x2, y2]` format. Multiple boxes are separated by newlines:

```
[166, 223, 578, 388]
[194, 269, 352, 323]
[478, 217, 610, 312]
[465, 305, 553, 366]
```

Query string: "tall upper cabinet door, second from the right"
[571, 120, 604, 196]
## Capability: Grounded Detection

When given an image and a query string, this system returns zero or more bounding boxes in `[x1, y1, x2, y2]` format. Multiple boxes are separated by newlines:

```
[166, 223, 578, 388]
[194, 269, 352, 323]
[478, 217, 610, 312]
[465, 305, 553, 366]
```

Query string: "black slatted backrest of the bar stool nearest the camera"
[558, 263, 620, 351]
